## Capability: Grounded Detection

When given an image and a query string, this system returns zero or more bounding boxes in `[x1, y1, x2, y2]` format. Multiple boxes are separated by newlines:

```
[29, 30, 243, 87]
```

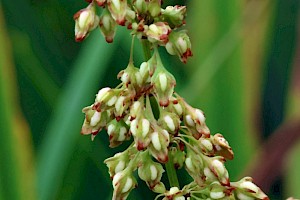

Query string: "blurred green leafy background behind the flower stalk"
[0, 0, 300, 200]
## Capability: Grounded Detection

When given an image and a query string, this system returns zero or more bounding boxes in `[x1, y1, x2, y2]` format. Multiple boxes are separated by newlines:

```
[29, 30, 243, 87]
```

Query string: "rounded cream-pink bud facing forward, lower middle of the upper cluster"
[146, 22, 171, 45]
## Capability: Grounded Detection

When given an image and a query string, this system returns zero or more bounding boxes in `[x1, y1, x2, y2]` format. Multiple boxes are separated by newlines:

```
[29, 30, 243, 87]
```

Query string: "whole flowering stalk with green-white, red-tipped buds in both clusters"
[74, 0, 269, 200]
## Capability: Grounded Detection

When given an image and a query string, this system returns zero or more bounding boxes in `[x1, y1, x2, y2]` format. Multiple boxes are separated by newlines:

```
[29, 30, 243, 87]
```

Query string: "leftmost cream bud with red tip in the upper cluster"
[73, 3, 99, 42]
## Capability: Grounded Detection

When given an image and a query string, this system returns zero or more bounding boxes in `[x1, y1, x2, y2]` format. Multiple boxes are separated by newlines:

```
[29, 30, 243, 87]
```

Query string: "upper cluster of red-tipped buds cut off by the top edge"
[74, 0, 192, 63]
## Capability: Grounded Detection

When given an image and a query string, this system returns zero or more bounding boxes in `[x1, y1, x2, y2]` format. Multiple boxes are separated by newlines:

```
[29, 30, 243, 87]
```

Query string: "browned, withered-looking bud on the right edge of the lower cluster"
[213, 133, 233, 160]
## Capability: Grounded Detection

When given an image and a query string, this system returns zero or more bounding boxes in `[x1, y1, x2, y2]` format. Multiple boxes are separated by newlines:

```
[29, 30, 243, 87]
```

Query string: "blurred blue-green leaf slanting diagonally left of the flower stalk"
[38, 29, 124, 200]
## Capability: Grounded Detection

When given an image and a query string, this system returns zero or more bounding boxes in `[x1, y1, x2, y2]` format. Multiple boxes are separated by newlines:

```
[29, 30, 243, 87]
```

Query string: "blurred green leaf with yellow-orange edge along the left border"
[0, 4, 36, 200]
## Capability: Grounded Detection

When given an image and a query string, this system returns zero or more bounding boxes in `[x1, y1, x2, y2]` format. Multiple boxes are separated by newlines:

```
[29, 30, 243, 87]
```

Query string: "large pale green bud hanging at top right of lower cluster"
[151, 68, 176, 107]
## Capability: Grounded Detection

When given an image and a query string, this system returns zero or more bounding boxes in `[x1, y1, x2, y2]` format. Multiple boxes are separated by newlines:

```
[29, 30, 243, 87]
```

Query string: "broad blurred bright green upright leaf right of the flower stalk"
[182, 1, 254, 180]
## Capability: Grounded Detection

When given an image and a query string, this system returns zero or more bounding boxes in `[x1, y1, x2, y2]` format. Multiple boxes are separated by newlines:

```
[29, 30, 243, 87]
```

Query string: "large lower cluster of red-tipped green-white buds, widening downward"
[81, 47, 267, 199]
